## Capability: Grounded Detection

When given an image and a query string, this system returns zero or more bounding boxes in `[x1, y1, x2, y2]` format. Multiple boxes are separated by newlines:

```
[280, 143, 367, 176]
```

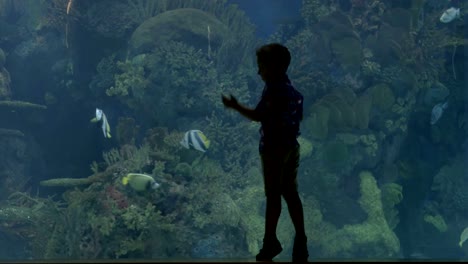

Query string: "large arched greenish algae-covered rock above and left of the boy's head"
[129, 8, 228, 56]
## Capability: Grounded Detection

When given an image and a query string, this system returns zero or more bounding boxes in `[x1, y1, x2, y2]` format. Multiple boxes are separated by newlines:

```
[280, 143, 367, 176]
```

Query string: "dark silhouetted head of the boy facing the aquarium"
[256, 43, 291, 81]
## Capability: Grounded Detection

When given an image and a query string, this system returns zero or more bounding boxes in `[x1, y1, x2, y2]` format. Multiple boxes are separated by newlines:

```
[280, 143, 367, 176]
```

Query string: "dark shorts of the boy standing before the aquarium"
[260, 144, 300, 196]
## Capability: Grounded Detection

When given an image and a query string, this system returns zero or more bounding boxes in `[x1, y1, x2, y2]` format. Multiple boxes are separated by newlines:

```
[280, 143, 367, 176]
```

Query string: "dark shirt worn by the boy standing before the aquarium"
[255, 75, 304, 153]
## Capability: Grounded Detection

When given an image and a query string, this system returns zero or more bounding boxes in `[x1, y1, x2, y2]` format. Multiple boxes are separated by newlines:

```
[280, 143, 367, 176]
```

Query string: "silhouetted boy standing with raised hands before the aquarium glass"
[222, 43, 309, 262]
